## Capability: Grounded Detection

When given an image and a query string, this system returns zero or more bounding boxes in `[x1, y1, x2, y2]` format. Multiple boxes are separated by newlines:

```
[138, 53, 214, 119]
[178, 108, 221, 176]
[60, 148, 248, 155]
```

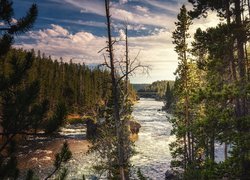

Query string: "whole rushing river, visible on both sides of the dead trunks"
[20, 98, 173, 180]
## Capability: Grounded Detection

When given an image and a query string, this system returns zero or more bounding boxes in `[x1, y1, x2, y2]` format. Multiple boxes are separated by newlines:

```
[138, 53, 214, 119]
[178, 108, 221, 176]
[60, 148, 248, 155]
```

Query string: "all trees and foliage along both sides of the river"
[0, 0, 250, 180]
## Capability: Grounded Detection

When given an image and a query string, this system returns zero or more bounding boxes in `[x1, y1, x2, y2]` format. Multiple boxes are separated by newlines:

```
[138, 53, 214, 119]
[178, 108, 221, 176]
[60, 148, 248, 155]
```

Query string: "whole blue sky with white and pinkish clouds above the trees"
[10, 0, 221, 83]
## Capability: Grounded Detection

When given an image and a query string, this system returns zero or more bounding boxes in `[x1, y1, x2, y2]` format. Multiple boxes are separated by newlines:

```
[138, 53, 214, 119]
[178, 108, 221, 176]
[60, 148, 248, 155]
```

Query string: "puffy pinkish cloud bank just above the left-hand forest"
[16, 24, 106, 64]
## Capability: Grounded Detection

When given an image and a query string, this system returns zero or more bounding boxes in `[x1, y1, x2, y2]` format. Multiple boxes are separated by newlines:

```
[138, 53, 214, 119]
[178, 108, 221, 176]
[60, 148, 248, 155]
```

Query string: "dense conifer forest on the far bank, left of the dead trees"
[22, 50, 111, 115]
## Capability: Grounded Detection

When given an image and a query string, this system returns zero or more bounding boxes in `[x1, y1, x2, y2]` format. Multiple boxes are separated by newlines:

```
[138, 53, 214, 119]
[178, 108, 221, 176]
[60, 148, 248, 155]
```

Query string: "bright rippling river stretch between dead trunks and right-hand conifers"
[132, 98, 174, 180]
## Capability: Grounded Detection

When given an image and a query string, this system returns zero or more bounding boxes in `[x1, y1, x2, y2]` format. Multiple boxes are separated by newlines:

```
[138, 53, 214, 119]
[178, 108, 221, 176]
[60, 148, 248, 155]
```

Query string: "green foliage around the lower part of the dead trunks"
[90, 90, 135, 179]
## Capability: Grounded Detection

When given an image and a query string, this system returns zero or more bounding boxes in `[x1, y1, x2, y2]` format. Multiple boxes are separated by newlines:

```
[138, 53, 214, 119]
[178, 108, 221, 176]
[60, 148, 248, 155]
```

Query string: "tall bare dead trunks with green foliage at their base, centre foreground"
[93, 0, 148, 180]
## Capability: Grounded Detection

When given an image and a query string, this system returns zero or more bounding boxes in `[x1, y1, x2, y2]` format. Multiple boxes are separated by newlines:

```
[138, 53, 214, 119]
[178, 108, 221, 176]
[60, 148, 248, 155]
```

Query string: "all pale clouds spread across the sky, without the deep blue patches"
[16, 0, 223, 82]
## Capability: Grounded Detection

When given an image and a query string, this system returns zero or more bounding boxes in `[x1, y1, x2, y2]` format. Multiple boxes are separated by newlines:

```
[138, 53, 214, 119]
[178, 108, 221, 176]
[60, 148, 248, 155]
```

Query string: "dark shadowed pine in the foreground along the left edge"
[0, 0, 72, 179]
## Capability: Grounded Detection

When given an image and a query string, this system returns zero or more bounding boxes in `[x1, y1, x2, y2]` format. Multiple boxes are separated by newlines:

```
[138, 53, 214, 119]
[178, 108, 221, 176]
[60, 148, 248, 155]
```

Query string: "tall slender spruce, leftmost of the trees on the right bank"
[173, 5, 192, 169]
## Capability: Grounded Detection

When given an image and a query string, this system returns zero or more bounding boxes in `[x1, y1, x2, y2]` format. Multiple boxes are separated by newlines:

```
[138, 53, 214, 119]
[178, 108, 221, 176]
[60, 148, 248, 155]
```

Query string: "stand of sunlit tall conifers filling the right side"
[170, 0, 250, 179]
